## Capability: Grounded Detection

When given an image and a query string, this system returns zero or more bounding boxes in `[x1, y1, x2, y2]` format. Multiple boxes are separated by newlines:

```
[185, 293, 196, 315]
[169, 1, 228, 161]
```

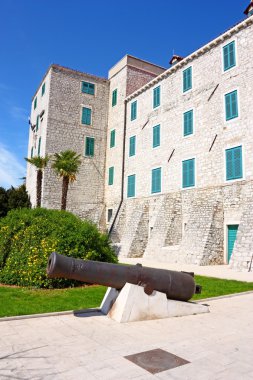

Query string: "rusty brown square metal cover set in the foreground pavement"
[125, 348, 190, 374]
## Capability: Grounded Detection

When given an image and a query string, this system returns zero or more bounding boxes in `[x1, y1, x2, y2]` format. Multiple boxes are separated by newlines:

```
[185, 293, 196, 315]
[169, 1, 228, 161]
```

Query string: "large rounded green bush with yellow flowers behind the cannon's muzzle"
[0, 208, 117, 288]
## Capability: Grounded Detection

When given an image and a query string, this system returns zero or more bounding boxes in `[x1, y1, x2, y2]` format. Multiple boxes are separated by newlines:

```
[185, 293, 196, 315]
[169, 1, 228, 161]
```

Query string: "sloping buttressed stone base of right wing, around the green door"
[111, 182, 253, 269]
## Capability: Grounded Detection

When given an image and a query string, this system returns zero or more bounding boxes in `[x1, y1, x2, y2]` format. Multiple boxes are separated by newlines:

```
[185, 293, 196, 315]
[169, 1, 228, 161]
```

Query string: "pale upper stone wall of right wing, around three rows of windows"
[125, 25, 253, 198]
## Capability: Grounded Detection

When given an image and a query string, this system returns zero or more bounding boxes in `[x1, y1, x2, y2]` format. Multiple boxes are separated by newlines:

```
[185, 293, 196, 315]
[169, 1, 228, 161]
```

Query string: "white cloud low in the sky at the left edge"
[0, 144, 26, 188]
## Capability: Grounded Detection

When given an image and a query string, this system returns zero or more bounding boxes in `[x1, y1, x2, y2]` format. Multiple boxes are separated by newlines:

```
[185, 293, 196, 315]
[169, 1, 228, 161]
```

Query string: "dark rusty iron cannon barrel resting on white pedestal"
[47, 252, 199, 301]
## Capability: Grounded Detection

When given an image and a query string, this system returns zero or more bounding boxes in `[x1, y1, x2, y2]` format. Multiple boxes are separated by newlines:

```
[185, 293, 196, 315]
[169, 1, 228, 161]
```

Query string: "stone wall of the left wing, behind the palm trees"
[28, 65, 109, 226]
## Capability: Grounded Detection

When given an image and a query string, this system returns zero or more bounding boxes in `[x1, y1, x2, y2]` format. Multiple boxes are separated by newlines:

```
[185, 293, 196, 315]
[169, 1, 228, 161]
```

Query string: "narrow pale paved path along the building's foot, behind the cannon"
[120, 258, 253, 282]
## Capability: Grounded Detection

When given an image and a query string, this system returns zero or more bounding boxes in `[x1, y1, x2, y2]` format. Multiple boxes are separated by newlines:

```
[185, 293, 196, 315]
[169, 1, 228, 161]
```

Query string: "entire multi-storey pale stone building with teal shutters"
[27, 2, 253, 270]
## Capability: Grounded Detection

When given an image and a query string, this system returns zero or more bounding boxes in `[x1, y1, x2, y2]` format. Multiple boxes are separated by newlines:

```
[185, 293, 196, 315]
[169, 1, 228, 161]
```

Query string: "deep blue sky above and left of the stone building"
[0, 0, 247, 188]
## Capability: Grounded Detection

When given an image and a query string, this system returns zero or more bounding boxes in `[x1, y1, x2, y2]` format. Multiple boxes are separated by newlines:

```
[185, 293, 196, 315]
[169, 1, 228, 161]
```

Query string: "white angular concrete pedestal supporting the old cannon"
[103, 283, 209, 323]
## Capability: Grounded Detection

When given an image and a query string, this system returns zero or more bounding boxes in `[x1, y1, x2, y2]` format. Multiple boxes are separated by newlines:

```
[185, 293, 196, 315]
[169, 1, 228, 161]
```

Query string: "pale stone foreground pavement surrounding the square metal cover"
[0, 294, 253, 380]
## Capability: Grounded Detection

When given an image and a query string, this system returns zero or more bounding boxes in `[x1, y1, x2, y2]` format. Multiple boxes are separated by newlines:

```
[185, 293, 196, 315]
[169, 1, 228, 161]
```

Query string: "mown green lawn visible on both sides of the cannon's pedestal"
[0, 276, 253, 317]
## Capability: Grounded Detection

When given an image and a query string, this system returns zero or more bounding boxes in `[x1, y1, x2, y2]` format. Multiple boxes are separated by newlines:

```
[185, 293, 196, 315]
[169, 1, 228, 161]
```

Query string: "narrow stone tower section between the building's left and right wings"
[105, 56, 164, 227]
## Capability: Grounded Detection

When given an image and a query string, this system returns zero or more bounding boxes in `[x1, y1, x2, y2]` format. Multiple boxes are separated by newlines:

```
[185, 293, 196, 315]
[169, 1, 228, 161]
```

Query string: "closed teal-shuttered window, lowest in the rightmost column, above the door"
[226, 146, 243, 181]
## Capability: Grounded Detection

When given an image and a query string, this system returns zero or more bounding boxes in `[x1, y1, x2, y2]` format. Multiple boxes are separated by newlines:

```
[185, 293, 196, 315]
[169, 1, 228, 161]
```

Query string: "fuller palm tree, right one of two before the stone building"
[52, 150, 81, 210]
